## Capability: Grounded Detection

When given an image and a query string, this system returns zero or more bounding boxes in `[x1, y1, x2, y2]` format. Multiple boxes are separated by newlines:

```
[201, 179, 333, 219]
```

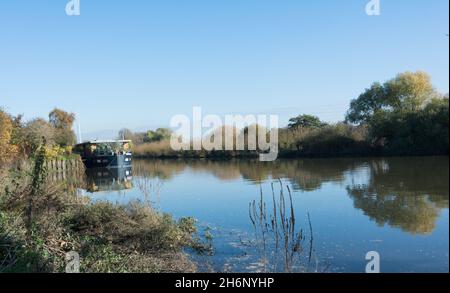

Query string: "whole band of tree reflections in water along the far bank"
[134, 157, 449, 234]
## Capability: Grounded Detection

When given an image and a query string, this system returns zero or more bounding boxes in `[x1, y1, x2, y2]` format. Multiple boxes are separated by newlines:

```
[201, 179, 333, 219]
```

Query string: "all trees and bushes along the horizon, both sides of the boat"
[0, 71, 449, 162]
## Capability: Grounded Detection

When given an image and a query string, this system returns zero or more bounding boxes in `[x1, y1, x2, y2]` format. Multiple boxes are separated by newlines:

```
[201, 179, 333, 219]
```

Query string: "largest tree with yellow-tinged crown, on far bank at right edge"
[346, 71, 448, 154]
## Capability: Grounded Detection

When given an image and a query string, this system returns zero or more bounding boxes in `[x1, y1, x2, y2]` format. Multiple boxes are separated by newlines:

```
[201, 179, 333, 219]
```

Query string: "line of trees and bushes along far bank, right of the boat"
[129, 71, 449, 157]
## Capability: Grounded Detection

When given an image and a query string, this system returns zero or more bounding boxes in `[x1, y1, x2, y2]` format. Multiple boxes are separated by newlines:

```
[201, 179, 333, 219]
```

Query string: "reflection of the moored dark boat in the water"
[86, 166, 133, 193]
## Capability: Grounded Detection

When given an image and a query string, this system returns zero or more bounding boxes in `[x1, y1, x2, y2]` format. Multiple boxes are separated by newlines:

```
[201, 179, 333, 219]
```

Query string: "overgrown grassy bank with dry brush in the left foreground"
[0, 157, 204, 272]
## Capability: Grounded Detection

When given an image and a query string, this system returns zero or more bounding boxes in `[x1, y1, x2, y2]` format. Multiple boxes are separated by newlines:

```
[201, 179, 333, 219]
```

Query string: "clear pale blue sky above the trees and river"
[0, 0, 449, 137]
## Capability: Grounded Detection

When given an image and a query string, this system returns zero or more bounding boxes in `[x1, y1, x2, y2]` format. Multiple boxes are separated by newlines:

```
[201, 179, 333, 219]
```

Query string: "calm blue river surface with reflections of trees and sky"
[79, 157, 449, 272]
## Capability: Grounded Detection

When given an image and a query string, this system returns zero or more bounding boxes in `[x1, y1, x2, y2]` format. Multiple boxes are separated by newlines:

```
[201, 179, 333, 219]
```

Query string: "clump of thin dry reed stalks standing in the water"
[249, 180, 317, 273]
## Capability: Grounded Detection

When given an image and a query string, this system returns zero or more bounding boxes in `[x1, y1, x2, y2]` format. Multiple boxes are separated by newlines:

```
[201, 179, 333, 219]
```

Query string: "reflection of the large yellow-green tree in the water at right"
[347, 158, 449, 234]
